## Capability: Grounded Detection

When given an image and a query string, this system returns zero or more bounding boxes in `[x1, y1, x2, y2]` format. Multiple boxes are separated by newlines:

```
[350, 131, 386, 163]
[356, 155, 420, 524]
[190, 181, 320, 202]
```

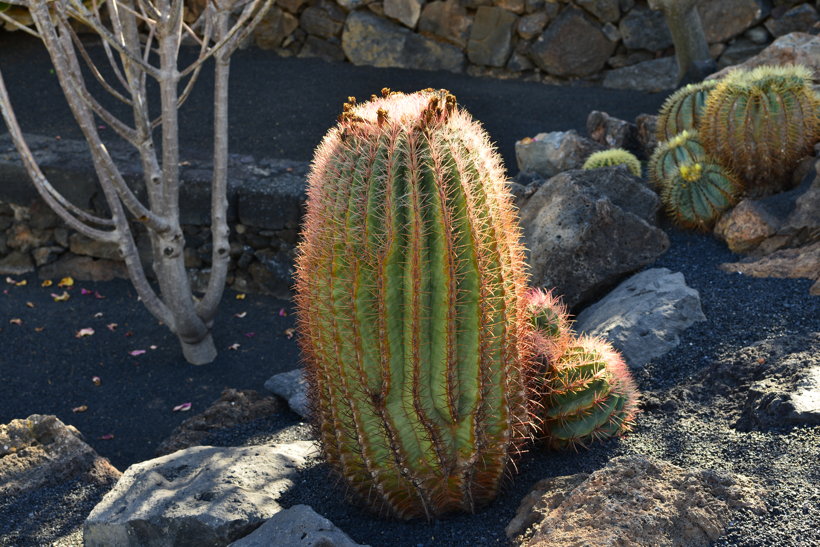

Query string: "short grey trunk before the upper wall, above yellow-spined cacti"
[649, 0, 713, 81]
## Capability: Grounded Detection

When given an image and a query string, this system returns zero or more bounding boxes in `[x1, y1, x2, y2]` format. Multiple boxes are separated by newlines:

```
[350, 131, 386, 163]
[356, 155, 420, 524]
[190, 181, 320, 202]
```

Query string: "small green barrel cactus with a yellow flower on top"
[661, 161, 742, 230]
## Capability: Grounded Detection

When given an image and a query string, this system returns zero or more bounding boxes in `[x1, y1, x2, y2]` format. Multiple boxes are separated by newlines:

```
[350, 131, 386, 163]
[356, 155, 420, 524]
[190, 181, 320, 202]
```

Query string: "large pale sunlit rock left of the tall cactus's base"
[83, 441, 318, 547]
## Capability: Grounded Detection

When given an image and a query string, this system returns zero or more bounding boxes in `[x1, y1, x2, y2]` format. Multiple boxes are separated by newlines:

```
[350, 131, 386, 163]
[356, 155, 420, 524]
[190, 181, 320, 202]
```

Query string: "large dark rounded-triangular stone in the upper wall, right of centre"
[530, 8, 615, 76]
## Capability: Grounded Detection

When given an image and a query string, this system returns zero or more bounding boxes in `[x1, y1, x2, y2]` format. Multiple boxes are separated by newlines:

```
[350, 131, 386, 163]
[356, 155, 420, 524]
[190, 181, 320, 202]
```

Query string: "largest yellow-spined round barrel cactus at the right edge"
[700, 65, 820, 197]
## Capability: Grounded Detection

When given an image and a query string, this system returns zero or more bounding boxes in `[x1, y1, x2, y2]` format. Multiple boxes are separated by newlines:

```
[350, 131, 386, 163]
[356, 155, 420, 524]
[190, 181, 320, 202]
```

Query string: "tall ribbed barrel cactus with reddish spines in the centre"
[296, 90, 529, 519]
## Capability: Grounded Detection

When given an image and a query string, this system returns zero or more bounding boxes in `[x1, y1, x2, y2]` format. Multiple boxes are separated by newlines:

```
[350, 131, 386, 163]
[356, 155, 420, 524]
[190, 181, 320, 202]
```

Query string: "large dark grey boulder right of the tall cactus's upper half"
[520, 167, 669, 308]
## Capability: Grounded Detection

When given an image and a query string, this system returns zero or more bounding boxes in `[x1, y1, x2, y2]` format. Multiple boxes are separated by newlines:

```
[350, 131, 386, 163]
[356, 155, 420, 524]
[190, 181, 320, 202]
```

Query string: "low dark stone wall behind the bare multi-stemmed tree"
[0, 135, 308, 298]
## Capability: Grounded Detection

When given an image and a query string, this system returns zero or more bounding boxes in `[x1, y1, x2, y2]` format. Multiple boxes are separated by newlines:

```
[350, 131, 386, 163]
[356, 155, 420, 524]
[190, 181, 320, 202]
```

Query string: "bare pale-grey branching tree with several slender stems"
[0, 0, 272, 365]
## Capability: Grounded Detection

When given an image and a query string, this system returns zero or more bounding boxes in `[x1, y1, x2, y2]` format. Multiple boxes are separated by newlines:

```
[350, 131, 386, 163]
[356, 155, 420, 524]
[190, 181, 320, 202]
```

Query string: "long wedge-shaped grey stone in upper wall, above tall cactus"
[342, 11, 465, 72]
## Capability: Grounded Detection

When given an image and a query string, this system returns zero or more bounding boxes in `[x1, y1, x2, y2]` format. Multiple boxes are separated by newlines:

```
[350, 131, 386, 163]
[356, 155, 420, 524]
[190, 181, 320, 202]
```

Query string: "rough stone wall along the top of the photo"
[255, 0, 820, 91]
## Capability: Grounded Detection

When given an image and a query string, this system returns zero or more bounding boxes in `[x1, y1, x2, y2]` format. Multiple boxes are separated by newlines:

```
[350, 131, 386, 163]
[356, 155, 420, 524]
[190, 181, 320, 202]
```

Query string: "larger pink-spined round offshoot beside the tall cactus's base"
[540, 335, 639, 449]
